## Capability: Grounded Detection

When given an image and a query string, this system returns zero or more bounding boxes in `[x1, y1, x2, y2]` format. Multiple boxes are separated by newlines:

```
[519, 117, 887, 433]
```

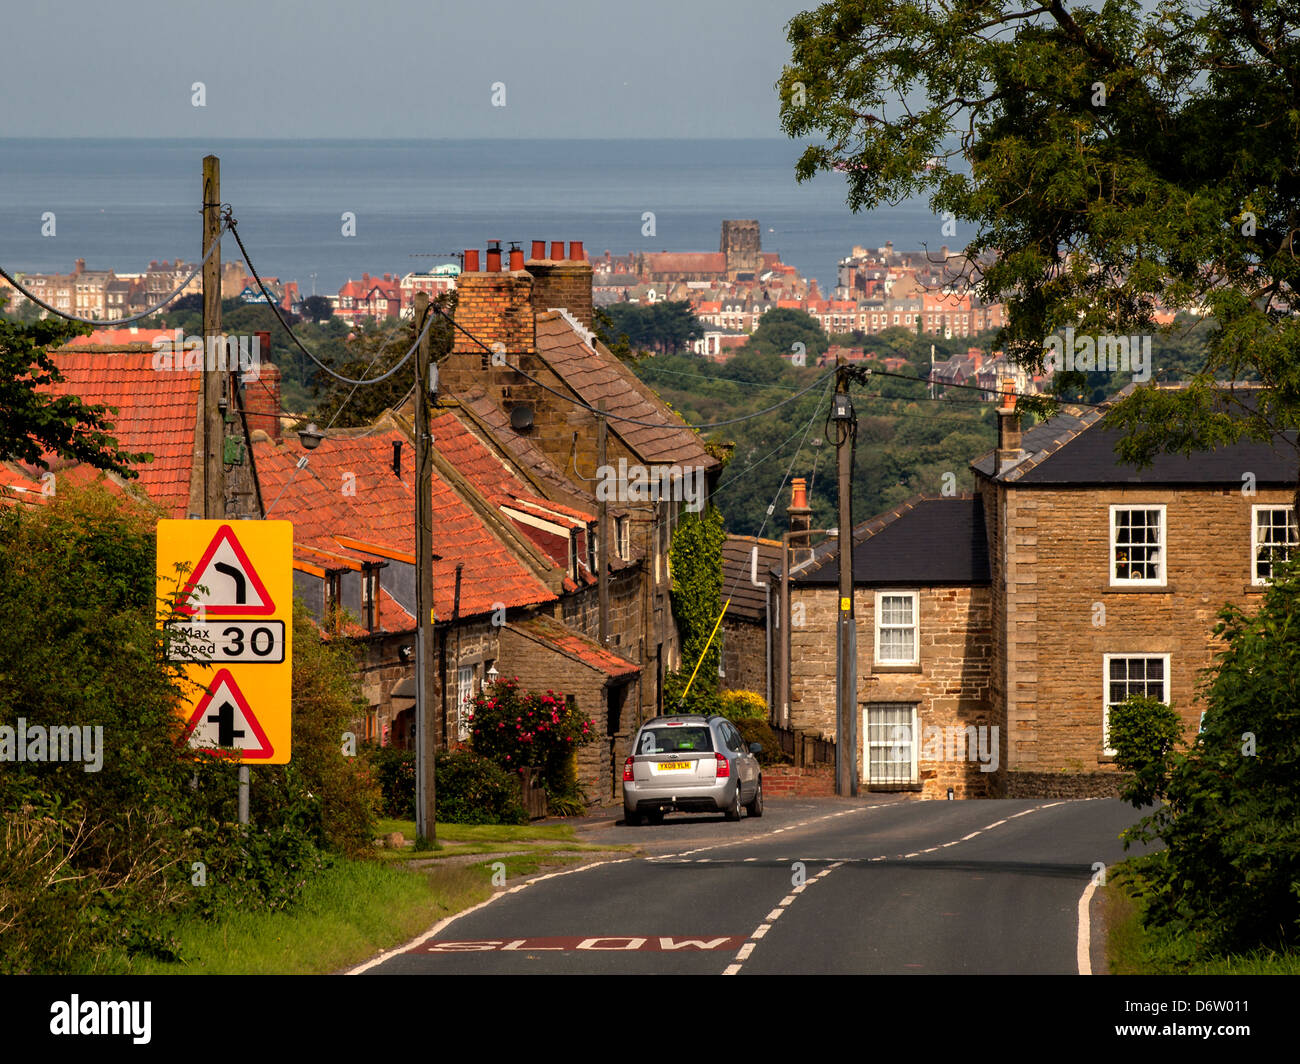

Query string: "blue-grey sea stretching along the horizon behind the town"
[0, 138, 941, 295]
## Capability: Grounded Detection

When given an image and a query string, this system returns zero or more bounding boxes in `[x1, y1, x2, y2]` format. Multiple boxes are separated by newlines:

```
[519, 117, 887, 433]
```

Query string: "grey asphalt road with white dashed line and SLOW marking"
[358, 796, 1136, 976]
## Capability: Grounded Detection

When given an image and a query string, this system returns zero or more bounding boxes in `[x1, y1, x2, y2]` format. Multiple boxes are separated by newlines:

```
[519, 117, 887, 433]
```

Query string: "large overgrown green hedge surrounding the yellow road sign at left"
[0, 488, 378, 972]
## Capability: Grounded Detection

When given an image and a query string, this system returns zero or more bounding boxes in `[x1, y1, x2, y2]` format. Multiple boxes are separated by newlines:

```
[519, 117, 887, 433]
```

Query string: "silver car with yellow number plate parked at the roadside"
[623, 715, 763, 825]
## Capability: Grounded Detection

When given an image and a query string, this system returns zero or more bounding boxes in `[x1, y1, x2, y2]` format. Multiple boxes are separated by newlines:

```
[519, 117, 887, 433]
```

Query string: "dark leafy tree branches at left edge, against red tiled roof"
[0, 319, 152, 477]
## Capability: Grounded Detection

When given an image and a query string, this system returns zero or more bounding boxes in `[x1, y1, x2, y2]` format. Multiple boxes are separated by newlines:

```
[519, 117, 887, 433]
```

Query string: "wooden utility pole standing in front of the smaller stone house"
[831, 349, 858, 797]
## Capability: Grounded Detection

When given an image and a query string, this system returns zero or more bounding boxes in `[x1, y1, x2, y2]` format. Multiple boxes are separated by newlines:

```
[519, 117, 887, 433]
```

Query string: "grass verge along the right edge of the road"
[1104, 866, 1300, 976]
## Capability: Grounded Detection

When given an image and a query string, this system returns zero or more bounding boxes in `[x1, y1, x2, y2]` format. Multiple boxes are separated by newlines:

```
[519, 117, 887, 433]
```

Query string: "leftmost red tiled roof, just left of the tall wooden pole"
[34, 345, 199, 518]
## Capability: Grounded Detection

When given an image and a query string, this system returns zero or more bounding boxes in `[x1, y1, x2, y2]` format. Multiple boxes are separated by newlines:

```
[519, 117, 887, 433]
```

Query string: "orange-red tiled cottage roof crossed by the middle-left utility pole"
[254, 429, 555, 624]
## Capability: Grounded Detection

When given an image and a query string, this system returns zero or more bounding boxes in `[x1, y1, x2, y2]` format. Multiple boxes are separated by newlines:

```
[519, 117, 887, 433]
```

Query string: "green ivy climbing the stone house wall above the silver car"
[664, 506, 727, 713]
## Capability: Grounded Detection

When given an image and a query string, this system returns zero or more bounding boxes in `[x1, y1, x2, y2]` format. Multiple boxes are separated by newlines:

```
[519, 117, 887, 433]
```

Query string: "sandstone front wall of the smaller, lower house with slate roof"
[790, 587, 1006, 797]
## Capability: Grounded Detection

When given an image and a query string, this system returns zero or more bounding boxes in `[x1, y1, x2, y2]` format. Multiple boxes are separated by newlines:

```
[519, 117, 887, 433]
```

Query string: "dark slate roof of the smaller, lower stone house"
[774, 496, 992, 587]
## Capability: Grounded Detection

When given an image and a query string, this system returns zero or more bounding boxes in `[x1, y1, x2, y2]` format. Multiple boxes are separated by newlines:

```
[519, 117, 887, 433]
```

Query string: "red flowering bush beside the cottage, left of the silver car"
[469, 679, 595, 793]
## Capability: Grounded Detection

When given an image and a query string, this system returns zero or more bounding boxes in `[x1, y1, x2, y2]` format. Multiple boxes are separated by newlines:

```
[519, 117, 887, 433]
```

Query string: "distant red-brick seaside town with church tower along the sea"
[0, 219, 1196, 397]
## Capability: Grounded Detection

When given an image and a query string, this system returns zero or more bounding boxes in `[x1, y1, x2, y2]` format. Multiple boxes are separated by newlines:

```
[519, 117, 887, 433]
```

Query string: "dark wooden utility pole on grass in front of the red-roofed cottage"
[415, 291, 436, 845]
